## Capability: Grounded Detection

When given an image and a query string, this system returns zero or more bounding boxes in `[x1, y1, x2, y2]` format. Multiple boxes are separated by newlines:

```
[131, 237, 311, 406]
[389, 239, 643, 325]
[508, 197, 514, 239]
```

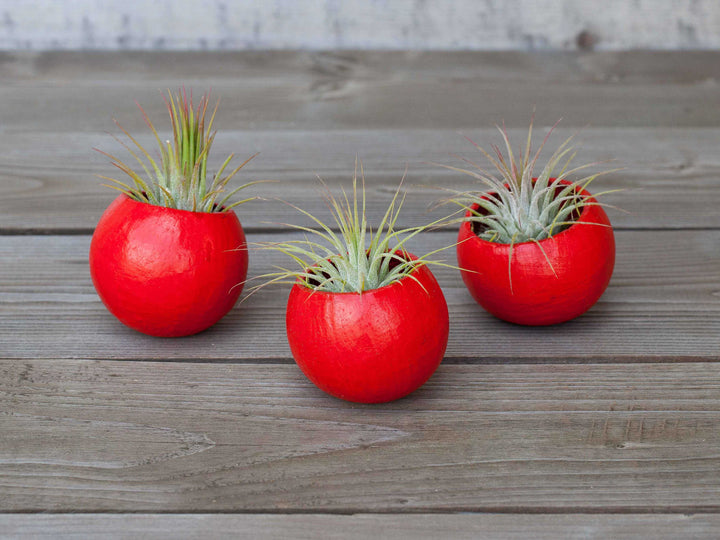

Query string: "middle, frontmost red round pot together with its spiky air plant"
[254, 164, 449, 403]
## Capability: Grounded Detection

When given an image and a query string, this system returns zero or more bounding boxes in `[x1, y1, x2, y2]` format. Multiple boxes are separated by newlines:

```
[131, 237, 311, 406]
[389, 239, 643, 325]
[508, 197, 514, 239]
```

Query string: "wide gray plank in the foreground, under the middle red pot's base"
[0, 360, 720, 513]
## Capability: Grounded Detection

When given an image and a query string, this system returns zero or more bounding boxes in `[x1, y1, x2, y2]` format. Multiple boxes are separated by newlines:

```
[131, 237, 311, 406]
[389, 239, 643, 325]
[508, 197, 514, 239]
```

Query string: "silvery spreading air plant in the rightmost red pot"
[438, 115, 617, 245]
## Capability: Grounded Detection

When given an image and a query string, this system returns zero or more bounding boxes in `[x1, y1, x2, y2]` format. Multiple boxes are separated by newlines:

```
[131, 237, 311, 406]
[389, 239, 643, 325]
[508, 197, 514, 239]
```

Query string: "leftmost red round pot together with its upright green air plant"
[90, 90, 256, 337]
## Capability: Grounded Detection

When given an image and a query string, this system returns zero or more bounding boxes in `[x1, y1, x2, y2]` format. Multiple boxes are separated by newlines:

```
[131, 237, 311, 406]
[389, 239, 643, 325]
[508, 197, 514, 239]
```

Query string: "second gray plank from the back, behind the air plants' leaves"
[0, 127, 720, 233]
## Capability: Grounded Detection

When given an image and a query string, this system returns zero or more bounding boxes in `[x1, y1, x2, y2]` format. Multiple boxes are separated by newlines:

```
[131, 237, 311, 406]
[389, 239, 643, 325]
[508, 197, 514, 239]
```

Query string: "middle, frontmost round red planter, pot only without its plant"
[286, 255, 449, 403]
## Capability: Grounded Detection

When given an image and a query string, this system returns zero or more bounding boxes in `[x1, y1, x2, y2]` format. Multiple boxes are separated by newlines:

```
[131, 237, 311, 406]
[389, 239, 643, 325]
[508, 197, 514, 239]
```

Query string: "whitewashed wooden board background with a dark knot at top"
[0, 0, 720, 50]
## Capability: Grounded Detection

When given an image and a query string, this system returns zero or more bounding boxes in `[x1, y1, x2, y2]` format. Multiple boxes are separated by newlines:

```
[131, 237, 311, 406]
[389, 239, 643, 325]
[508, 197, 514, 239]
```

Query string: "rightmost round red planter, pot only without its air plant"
[457, 182, 615, 326]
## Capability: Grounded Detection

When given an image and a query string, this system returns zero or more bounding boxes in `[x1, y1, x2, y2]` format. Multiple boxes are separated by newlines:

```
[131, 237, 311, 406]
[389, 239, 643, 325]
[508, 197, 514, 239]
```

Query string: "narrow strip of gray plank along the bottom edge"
[0, 514, 720, 540]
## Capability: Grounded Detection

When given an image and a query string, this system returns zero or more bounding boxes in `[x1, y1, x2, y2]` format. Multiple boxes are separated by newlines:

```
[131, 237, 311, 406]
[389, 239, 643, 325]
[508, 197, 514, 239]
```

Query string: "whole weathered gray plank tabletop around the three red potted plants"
[0, 51, 720, 528]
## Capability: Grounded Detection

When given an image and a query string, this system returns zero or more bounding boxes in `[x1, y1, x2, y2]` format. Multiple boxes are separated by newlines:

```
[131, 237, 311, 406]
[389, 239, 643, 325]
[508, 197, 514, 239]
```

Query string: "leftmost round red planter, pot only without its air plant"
[90, 195, 248, 337]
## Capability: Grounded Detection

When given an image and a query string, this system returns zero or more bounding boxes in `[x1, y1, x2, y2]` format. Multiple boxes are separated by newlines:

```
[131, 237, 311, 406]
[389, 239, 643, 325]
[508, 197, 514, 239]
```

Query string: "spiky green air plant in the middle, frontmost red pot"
[253, 159, 452, 293]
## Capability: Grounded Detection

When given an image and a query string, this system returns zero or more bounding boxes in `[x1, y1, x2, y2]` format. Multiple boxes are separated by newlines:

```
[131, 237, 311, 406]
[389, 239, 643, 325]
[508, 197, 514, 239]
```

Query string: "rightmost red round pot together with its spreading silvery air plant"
[444, 117, 615, 326]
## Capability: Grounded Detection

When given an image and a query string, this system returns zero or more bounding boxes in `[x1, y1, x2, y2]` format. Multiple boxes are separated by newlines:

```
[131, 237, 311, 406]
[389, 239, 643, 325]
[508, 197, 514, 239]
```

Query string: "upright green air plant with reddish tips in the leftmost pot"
[96, 88, 258, 212]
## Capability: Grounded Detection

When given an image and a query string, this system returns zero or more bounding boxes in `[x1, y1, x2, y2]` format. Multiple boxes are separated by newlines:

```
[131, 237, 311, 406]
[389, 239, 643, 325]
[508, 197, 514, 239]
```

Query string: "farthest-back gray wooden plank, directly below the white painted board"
[0, 51, 720, 132]
